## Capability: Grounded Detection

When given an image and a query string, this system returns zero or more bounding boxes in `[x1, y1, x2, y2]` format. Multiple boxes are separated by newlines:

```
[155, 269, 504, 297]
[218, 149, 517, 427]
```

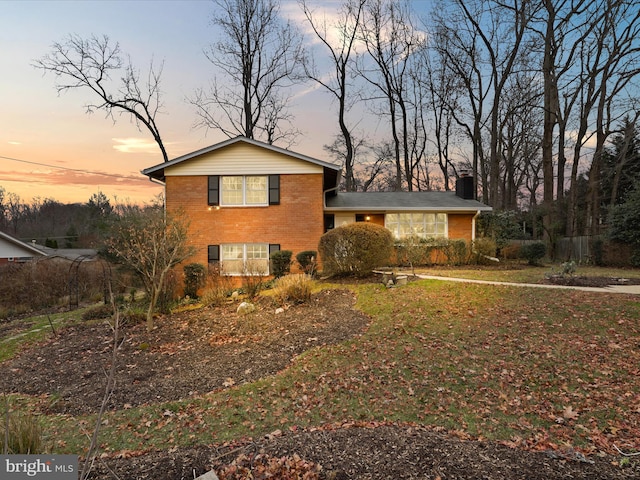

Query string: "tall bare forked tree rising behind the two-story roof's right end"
[299, 0, 367, 192]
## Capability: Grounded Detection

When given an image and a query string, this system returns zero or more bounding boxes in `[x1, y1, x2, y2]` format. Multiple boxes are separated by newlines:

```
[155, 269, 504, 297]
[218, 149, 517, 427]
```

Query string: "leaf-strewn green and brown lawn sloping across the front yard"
[7, 280, 640, 460]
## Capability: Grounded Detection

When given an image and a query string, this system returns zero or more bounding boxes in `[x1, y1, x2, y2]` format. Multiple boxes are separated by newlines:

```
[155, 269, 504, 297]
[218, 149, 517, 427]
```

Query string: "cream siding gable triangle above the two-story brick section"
[164, 143, 323, 177]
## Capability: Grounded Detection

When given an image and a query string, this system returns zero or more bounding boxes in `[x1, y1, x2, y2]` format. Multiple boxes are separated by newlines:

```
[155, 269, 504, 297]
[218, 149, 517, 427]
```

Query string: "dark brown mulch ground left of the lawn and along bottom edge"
[0, 284, 640, 480]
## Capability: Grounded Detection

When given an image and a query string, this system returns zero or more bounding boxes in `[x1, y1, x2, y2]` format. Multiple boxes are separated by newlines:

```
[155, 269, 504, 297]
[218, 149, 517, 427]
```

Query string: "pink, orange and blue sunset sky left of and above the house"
[0, 0, 376, 203]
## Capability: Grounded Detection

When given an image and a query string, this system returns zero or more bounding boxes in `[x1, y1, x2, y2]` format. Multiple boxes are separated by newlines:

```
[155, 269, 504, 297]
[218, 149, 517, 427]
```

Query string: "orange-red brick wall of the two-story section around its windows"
[166, 174, 324, 264]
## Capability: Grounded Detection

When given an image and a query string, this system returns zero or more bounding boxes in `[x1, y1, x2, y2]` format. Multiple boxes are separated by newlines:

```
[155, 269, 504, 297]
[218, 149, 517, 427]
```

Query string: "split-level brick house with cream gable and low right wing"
[142, 137, 491, 275]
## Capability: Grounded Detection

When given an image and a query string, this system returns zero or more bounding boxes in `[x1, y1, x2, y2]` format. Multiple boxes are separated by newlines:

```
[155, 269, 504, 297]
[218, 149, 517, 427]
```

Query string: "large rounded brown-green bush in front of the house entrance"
[318, 222, 393, 277]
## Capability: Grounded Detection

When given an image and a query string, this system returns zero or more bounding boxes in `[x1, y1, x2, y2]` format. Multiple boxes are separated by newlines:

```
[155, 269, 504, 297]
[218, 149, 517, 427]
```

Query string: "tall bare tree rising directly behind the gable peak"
[190, 0, 303, 144]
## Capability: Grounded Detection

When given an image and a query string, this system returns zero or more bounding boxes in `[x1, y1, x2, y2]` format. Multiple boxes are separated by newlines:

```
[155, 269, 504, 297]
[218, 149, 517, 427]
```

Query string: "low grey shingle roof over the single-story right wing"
[326, 192, 492, 212]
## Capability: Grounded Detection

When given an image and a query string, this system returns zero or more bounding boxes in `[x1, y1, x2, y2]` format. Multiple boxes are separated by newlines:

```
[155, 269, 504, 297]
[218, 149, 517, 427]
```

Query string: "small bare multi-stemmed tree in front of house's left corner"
[107, 205, 194, 330]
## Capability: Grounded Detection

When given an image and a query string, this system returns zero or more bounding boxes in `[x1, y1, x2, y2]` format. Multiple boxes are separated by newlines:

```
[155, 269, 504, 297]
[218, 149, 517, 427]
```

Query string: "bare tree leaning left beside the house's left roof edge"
[34, 35, 169, 162]
